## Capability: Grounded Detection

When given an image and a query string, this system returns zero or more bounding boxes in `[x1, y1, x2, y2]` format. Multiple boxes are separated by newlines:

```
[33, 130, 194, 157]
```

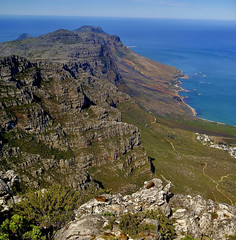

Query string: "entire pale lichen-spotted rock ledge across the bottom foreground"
[54, 179, 236, 240]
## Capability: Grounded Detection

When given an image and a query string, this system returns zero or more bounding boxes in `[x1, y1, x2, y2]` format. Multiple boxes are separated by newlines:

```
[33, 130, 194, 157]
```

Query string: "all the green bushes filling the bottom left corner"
[0, 185, 106, 240]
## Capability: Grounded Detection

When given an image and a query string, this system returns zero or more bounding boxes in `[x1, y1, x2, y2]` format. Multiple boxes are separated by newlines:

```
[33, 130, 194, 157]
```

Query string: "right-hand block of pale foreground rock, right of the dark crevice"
[170, 195, 236, 240]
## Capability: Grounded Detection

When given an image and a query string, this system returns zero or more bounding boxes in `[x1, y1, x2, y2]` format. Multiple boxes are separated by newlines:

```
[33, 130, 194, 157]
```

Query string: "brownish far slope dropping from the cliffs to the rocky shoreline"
[115, 47, 195, 117]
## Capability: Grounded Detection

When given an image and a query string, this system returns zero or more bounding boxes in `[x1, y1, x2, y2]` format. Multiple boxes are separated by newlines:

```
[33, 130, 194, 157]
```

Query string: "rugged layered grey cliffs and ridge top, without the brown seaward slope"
[0, 27, 149, 195]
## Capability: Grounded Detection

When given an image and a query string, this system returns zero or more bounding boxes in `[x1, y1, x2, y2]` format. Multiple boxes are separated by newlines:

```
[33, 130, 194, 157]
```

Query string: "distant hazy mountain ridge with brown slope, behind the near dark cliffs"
[0, 26, 193, 117]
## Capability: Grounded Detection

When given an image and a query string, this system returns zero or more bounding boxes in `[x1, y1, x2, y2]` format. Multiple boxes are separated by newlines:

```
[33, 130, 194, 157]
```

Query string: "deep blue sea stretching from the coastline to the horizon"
[0, 16, 236, 125]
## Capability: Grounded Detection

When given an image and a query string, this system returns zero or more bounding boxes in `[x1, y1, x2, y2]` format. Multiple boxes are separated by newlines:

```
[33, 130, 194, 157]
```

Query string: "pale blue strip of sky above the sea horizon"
[0, 0, 236, 20]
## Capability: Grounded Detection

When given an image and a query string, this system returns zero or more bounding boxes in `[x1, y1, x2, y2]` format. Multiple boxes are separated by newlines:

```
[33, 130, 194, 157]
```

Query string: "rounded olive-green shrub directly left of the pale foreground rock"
[14, 185, 81, 228]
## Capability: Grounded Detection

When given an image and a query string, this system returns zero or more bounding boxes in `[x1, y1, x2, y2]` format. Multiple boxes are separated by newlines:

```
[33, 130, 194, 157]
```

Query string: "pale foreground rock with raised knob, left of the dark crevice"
[54, 179, 170, 240]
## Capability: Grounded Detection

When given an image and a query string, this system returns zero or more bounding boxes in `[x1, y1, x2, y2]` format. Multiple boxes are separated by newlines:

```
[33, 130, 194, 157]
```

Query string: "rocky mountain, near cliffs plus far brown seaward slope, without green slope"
[0, 26, 195, 191]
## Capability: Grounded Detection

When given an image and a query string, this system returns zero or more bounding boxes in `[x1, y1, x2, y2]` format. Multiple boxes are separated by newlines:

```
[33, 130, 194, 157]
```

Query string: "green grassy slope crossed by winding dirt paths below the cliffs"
[119, 100, 236, 204]
